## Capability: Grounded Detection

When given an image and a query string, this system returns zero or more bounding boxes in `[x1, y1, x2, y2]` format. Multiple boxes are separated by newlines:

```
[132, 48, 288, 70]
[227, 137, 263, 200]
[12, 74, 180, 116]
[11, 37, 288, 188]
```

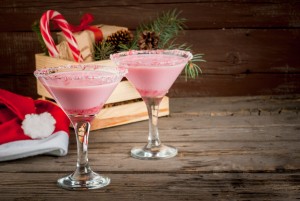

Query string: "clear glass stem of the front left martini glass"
[74, 120, 91, 176]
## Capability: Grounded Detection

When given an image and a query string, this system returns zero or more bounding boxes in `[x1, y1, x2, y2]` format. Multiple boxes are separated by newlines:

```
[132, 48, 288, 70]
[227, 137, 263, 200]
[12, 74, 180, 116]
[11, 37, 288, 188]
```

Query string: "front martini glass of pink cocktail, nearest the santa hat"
[34, 64, 126, 190]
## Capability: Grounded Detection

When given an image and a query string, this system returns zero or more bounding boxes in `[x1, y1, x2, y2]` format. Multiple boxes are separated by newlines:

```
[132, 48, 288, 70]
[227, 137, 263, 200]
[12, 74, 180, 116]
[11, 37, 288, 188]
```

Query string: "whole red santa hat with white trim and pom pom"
[0, 89, 70, 161]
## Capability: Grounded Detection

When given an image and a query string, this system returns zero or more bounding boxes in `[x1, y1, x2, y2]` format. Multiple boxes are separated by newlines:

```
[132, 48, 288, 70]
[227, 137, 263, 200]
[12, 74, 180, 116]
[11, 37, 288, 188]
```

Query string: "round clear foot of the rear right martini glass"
[131, 144, 178, 160]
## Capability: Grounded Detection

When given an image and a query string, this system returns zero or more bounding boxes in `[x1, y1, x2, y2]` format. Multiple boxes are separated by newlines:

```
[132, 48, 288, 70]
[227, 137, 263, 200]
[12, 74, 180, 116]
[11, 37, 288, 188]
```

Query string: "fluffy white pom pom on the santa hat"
[22, 112, 56, 139]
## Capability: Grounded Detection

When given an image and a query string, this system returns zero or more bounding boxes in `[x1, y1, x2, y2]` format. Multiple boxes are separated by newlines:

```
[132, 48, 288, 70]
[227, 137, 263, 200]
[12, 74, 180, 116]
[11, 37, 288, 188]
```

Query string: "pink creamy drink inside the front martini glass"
[41, 71, 118, 116]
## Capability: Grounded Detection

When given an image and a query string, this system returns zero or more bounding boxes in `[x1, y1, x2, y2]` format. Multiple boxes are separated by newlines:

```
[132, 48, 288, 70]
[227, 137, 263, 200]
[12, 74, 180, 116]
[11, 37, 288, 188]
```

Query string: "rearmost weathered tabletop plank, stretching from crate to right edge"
[170, 94, 300, 116]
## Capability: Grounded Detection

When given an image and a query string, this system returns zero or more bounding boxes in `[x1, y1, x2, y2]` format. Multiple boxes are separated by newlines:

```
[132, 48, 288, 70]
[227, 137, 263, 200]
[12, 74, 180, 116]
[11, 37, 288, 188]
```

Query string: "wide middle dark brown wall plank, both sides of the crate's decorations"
[0, 29, 300, 75]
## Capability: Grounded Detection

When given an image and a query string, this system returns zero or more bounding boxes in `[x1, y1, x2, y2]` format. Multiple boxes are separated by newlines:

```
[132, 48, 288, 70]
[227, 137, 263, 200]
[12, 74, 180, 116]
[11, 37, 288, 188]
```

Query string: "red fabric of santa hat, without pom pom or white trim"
[0, 89, 70, 144]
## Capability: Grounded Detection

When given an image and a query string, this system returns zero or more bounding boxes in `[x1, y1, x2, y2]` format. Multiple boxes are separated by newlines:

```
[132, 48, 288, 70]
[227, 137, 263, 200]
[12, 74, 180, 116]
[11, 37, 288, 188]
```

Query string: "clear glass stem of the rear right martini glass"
[143, 97, 162, 149]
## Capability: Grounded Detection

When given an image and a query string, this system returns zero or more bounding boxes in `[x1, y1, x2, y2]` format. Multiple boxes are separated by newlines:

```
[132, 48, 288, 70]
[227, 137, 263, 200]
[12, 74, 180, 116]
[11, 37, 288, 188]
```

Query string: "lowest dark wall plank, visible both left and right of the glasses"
[0, 74, 300, 98]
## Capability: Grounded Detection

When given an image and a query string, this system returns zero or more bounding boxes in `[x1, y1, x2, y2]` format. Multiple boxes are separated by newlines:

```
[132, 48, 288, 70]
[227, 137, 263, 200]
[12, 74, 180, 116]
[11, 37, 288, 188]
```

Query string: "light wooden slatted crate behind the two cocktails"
[35, 54, 169, 130]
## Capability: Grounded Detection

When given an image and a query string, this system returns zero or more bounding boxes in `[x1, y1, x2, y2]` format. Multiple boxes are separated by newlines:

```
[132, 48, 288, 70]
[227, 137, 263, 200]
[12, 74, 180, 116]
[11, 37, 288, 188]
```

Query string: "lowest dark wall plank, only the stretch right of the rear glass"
[169, 74, 300, 97]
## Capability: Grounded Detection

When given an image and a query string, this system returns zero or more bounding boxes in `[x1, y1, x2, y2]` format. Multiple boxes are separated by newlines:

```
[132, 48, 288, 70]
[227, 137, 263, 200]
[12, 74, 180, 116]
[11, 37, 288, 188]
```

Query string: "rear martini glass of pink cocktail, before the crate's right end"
[110, 50, 193, 160]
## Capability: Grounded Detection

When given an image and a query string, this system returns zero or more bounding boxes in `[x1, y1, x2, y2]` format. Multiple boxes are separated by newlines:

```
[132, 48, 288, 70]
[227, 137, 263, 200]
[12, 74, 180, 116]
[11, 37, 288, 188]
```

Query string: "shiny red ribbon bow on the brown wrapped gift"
[69, 13, 103, 42]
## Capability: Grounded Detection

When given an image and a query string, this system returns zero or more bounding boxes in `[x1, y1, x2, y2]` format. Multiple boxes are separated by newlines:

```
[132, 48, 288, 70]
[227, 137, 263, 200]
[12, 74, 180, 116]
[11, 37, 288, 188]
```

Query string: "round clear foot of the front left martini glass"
[57, 171, 110, 190]
